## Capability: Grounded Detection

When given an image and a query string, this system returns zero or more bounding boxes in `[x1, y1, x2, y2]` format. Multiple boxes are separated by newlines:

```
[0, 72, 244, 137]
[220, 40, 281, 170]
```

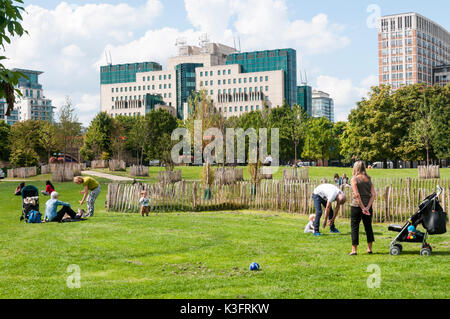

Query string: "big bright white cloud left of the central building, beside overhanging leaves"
[6, 0, 162, 124]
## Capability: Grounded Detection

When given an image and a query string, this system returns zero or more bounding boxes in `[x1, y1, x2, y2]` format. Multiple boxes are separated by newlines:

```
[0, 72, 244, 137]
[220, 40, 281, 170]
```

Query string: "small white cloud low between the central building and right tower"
[316, 75, 377, 121]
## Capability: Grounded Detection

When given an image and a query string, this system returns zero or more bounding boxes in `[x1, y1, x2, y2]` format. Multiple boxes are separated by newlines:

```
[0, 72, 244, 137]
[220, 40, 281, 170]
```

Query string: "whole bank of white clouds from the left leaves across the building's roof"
[6, 0, 356, 124]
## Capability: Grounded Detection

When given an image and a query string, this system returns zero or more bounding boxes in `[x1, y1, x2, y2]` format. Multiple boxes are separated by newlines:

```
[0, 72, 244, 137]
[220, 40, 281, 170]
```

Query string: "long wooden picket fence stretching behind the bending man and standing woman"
[106, 179, 450, 222]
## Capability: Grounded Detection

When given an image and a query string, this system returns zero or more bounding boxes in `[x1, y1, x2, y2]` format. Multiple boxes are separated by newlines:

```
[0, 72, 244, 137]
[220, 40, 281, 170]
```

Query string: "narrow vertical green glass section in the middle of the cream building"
[175, 63, 203, 119]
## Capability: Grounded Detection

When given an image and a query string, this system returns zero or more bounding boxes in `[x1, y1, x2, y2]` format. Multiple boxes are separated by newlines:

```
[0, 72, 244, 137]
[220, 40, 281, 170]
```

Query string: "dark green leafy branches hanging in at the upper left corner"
[0, 0, 27, 116]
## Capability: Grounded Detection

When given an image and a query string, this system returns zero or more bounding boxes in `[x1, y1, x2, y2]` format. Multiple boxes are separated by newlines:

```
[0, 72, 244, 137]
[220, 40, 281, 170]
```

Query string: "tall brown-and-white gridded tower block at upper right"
[378, 13, 450, 89]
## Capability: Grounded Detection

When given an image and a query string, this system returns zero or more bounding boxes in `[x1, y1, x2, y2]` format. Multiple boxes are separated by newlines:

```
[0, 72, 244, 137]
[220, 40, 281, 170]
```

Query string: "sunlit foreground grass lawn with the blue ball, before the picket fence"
[0, 181, 450, 298]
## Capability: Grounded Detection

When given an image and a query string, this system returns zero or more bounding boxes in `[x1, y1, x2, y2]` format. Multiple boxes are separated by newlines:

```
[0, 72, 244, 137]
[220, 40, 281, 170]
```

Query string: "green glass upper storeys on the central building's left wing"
[100, 62, 162, 84]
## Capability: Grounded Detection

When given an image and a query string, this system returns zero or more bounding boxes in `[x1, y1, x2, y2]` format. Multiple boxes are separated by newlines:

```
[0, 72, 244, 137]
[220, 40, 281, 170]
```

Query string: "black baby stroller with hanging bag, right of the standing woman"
[389, 185, 447, 256]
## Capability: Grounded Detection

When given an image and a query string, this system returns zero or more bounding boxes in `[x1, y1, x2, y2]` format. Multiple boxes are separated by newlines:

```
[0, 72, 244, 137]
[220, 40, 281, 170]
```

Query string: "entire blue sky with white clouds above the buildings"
[1, 0, 450, 126]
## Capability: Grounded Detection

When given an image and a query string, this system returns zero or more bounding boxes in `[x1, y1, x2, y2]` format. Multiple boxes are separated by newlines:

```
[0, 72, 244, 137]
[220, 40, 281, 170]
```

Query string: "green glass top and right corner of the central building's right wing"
[226, 49, 297, 106]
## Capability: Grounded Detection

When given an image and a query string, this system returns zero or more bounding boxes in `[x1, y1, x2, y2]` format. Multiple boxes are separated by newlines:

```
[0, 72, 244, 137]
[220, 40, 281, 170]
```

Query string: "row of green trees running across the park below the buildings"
[0, 85, 450, 170]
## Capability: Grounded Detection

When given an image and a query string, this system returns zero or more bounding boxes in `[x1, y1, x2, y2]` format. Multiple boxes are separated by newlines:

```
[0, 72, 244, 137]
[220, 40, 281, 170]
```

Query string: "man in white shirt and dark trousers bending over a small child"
[312, 184, 346, 236]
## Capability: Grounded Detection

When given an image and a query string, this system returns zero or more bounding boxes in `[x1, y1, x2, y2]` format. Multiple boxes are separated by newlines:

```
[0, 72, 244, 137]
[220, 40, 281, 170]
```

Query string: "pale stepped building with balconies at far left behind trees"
[0, 69, 55, 125]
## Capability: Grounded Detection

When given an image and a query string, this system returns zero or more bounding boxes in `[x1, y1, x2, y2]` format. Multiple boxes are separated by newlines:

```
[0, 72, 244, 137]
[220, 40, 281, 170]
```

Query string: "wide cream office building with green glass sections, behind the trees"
[100, 39, 297, 119]
